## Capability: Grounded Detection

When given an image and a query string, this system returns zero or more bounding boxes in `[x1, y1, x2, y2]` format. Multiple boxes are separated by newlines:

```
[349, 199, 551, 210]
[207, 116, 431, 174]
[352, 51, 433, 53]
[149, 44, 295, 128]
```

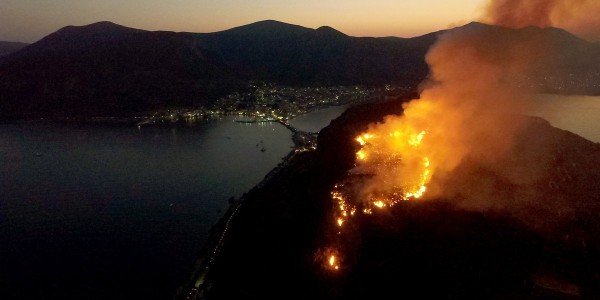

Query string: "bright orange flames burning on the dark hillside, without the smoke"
[326, 128, 431, 270]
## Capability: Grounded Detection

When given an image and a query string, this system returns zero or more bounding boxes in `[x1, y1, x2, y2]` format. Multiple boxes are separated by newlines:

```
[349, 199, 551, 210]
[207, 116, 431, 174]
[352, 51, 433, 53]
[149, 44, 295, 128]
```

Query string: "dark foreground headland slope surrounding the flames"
[200, 95, 600, 299]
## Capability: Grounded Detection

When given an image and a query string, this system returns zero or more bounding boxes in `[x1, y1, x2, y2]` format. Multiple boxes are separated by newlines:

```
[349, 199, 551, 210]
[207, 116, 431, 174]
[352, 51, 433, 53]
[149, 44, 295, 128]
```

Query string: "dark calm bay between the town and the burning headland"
[0, 107, 345, 299]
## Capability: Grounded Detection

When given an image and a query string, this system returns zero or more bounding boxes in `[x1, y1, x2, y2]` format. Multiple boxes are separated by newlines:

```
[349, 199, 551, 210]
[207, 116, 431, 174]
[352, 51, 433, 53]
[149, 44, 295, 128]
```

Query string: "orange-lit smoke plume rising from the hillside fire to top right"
[352, 0, 600, 227]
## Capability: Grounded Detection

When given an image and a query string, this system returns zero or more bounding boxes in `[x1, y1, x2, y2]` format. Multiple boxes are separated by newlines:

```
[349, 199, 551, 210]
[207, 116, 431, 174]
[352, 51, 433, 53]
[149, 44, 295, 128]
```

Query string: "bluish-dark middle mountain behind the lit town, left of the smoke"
[196, 21, 435, 85]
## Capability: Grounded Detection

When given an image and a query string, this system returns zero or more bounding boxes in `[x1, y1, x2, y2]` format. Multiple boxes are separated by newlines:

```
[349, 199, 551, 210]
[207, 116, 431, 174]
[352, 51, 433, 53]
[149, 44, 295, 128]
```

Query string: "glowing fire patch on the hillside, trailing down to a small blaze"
[322, 127, 431, 270]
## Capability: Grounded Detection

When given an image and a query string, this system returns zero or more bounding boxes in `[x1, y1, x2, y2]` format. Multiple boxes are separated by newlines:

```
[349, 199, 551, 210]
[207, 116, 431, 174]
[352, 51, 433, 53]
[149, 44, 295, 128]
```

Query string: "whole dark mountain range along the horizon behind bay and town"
[0, 20, 600, 118]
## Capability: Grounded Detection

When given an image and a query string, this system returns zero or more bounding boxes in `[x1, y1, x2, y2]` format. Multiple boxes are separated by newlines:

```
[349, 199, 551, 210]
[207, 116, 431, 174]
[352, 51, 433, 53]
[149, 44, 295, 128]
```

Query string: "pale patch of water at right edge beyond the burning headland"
[530, 94, 600, 143]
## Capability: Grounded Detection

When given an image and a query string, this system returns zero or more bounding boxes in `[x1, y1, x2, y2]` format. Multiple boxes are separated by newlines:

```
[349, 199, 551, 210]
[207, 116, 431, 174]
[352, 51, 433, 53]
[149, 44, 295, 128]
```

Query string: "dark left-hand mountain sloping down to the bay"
[0, 22, 229, 118]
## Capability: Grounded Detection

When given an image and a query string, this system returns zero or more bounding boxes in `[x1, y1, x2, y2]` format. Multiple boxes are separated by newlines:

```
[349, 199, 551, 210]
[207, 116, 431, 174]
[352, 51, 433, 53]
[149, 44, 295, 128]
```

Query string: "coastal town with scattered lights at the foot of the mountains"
[138, 82, 409, 126]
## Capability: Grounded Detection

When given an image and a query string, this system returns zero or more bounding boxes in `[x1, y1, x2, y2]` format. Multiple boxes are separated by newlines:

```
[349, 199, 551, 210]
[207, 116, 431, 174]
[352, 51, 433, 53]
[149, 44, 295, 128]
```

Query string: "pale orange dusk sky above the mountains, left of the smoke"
[0, 0, 486, 42]
